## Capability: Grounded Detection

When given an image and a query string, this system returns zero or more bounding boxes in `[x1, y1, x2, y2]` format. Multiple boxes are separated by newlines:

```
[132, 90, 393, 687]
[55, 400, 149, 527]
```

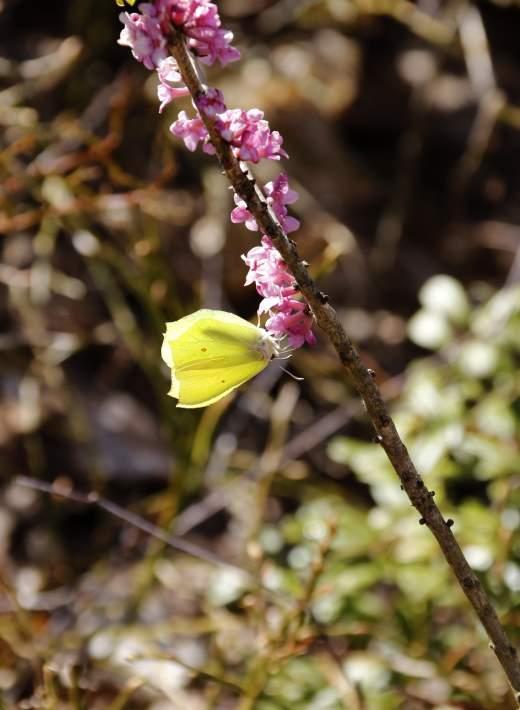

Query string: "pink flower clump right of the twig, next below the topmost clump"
[216, 108, 289, 163]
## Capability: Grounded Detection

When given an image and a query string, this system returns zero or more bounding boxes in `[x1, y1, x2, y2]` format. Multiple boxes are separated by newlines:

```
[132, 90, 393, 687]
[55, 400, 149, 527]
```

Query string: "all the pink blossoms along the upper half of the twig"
[119, 0, 316, 348]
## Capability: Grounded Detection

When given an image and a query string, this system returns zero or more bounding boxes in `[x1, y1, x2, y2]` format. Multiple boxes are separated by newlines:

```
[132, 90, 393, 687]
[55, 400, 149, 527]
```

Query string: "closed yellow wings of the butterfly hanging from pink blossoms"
[162, 310, 269, 408]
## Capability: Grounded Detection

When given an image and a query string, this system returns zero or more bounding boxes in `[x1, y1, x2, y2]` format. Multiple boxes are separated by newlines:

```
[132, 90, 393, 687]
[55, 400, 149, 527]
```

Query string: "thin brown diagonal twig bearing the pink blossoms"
[170, 28, 520, 707]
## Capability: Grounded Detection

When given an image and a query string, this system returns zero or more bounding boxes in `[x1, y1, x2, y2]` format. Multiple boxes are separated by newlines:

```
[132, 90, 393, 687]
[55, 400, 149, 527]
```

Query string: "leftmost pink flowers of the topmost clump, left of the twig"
[118, 3, 168, 69]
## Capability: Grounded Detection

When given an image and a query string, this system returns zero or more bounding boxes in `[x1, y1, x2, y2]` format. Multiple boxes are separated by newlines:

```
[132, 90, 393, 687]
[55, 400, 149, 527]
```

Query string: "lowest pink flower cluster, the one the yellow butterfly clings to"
[242, 236, 316, 348]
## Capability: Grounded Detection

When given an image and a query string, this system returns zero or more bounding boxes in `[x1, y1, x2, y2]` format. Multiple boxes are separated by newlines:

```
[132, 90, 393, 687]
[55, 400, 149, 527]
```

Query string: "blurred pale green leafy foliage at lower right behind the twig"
[244, 277, 520, 710]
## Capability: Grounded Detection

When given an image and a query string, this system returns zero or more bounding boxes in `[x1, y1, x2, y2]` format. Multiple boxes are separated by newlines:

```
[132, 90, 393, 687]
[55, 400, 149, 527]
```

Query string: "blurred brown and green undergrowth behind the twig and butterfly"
[0, 0, 520, 710]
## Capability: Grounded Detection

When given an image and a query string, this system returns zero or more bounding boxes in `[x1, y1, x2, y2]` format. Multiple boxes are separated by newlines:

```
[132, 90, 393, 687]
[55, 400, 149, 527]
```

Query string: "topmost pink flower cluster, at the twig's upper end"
[119, 0, 240, 69]
